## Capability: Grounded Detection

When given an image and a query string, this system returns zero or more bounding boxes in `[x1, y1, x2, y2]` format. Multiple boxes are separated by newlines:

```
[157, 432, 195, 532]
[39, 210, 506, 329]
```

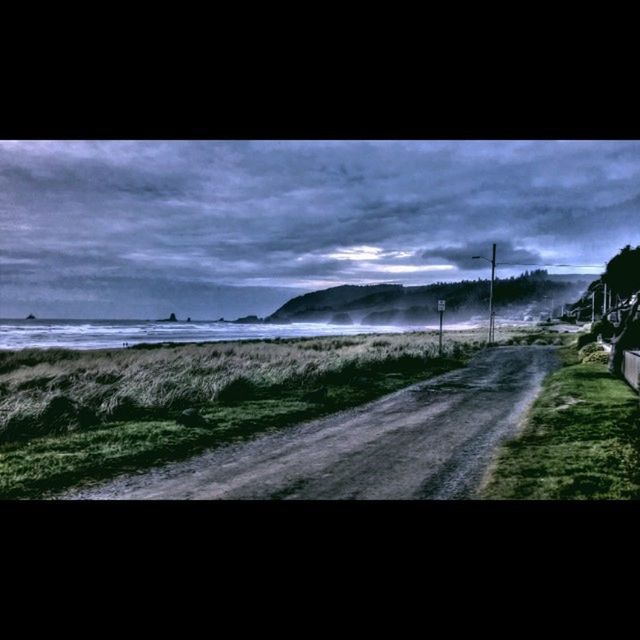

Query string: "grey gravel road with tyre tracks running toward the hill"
[63, 346, 559, 500]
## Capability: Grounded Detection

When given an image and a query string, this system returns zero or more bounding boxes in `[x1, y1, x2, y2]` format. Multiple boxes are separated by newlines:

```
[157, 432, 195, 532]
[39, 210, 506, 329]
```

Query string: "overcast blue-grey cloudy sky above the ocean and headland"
[0, 141, 640, 319]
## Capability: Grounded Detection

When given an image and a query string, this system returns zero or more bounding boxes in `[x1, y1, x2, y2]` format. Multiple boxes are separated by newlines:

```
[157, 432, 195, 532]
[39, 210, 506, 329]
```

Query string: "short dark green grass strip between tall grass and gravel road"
[0, 356, 468, 499]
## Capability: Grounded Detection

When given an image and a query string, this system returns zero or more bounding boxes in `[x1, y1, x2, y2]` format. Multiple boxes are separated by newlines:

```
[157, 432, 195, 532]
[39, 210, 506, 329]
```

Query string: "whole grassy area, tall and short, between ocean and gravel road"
[0, 330, 559, 499]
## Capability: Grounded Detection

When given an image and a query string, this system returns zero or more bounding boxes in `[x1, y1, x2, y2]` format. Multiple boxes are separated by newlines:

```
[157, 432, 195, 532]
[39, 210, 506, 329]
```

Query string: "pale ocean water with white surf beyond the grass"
[0, 319, 458, 350]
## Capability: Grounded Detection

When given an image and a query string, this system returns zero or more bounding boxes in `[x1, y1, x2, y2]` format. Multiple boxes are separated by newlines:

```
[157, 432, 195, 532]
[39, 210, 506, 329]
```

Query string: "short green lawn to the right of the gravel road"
[481, 348, 640, 500]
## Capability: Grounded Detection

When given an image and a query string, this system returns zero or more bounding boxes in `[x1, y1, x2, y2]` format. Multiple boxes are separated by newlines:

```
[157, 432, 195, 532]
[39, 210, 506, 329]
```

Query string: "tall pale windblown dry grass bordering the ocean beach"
[0, 332, 490, 441]
